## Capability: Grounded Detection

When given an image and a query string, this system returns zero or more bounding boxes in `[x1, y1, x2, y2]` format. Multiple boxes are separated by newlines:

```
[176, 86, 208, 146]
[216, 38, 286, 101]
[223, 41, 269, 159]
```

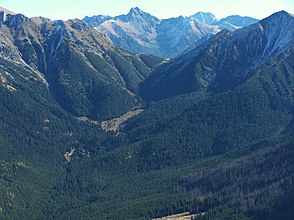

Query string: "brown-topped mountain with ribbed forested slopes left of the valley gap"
[0, 11, 161, 119]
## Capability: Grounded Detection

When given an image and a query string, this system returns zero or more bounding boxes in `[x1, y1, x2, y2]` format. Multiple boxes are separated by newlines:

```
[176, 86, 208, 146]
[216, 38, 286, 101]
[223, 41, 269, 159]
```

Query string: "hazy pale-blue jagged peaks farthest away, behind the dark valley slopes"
[83, 7, 257, 57]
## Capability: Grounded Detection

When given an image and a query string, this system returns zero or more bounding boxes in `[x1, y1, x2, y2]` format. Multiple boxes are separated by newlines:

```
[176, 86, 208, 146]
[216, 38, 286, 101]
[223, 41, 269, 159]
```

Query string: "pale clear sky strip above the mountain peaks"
[0, 0, 294, 20]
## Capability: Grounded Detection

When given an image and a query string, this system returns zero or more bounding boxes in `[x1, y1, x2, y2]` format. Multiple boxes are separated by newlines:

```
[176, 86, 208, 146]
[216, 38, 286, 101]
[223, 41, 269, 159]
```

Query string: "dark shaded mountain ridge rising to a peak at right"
[142, 11, 294, 99]
